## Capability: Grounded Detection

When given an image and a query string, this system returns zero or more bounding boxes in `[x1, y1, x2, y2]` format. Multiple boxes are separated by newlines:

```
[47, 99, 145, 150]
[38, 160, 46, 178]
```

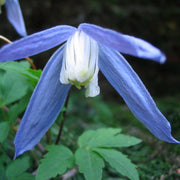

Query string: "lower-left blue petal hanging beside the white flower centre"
[15, 47, 71, 157]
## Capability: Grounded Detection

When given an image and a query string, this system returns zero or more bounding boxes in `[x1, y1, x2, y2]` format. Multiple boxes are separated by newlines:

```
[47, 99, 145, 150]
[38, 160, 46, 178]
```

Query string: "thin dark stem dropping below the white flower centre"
[55, 92, 70, 144]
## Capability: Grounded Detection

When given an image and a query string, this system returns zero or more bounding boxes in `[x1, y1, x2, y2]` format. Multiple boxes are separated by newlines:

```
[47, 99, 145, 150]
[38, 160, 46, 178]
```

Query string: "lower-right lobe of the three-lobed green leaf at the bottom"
[94, 148, 139, 180]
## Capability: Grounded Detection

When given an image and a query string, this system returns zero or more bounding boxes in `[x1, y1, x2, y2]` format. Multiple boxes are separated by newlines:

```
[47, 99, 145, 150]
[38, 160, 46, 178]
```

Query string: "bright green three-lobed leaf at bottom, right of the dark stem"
[75, 128, 141, 180]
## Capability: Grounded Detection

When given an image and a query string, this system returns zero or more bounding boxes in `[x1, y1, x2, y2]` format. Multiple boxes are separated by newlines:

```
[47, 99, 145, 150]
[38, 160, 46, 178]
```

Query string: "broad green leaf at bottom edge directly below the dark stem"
[36, 145, 74, 180]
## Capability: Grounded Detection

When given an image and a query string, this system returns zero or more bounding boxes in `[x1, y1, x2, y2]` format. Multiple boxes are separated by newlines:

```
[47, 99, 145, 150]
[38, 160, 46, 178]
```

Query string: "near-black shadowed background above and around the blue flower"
[0, 0, 180, 99]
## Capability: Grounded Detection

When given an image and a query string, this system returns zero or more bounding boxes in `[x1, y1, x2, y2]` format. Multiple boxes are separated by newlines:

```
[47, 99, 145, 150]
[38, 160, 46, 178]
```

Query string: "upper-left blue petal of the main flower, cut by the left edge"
[0, 25, 76, 62]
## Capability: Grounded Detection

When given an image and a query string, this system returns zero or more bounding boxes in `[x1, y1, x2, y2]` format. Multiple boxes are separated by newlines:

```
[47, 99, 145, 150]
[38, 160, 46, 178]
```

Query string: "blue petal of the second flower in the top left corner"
[5, 0, 27, 36]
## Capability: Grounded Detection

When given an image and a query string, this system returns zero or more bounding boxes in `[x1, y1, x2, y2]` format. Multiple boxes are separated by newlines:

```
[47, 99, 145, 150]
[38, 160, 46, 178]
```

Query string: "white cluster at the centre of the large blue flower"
[60, 30, 100, 97]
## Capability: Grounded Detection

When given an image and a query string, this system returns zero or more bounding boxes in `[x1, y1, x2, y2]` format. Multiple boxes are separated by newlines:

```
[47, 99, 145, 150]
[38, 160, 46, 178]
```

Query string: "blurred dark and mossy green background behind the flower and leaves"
[0, 0, 180, 180]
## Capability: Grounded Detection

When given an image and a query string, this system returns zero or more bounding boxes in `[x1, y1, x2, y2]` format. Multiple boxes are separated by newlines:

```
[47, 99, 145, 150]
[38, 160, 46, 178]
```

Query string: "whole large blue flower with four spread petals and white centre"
[0, 23, 179, 156]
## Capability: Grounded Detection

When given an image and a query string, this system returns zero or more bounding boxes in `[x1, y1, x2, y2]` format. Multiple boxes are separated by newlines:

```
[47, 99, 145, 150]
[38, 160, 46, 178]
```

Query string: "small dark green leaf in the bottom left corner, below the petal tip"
[6, 156, 30, 180]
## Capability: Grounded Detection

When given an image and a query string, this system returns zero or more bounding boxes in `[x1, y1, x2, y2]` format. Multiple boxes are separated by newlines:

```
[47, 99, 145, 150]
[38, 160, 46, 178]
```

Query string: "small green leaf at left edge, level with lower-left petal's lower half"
[0, 122, 10, 143]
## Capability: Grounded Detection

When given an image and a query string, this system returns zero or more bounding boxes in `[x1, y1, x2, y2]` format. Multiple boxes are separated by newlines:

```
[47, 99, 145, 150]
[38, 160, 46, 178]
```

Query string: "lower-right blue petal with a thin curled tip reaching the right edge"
[99, 47, 180, 143]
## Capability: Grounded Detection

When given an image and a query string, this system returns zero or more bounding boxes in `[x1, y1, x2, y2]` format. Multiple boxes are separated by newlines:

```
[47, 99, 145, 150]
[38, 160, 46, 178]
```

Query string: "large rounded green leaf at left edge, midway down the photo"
[0, 72, 29, 107]
